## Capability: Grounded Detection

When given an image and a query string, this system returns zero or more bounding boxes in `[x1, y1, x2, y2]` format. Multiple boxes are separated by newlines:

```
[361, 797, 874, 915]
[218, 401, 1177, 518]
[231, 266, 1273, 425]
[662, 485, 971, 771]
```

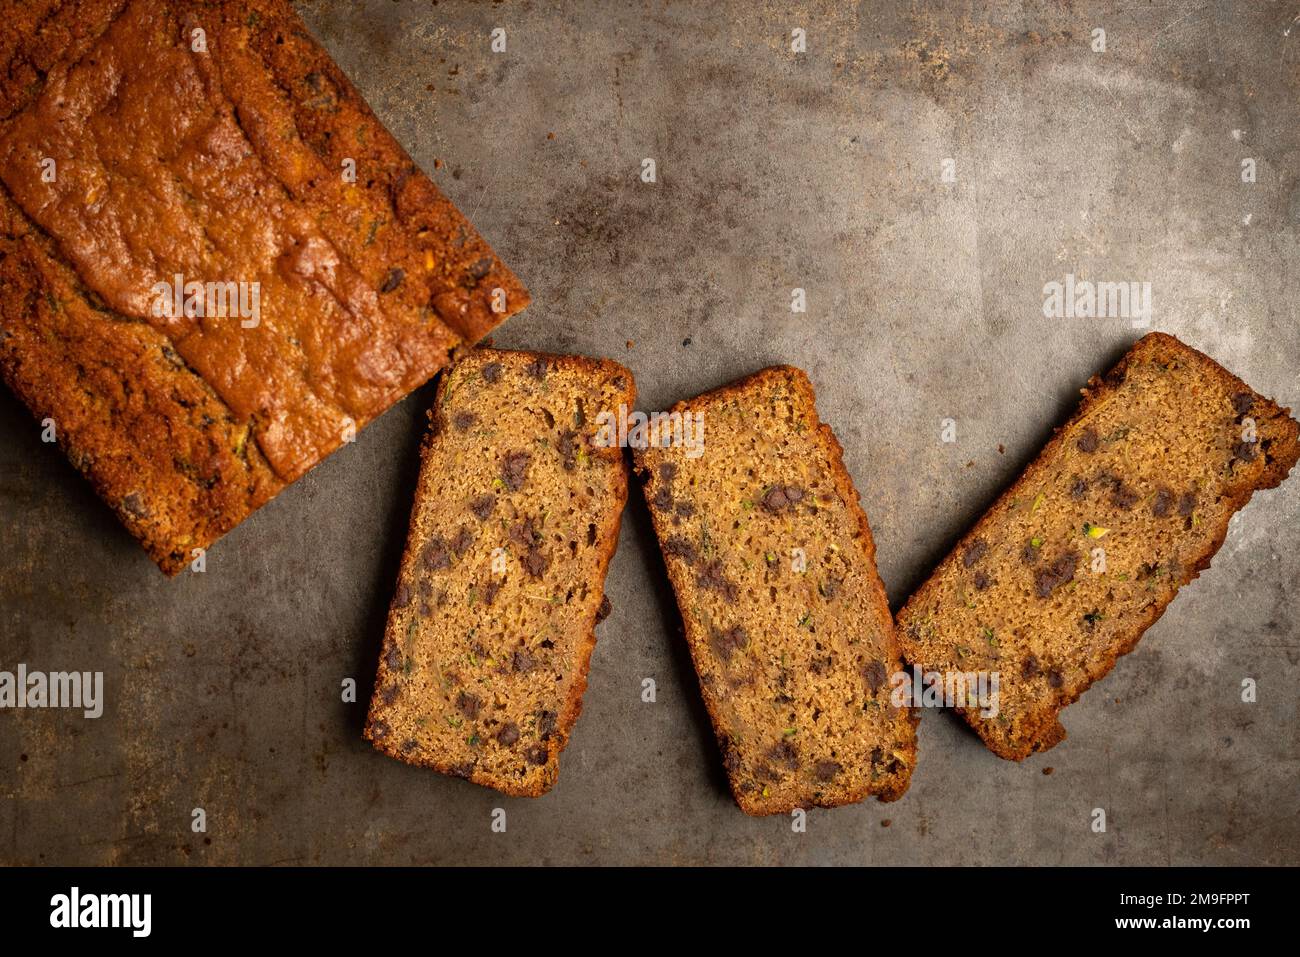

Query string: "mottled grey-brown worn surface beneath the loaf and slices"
[0, 0, 1300, 863]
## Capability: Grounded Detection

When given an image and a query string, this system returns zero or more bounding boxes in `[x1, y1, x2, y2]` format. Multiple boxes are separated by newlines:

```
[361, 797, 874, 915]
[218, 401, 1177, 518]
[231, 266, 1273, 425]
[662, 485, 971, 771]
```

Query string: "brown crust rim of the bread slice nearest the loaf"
[364, 348, 636, 797]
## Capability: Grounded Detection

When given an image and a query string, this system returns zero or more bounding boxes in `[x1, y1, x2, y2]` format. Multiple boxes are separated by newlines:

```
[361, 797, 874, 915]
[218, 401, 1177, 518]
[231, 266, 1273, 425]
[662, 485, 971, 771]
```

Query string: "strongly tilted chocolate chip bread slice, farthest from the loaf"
[898, 333, 1300, 761]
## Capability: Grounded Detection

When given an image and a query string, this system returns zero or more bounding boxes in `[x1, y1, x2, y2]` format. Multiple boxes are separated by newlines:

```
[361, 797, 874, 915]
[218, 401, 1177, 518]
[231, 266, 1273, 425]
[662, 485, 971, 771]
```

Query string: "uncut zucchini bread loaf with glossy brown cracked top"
[0, 0, 528, 573]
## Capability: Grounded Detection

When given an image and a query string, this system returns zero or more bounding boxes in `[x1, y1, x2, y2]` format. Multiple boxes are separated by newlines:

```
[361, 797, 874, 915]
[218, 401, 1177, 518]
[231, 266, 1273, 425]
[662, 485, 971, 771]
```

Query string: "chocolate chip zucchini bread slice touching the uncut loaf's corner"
[365, 350, 636, 797]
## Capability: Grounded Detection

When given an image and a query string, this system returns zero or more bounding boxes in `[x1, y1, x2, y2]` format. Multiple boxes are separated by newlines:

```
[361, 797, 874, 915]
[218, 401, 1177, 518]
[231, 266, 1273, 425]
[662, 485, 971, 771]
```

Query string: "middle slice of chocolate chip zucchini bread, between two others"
[634, 365, 917, 814]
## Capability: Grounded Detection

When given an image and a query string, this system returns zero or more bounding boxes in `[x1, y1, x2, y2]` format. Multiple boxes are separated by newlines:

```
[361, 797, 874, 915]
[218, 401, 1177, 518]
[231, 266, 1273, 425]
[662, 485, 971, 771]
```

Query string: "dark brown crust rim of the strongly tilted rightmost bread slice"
[898, 333, 1300, 761]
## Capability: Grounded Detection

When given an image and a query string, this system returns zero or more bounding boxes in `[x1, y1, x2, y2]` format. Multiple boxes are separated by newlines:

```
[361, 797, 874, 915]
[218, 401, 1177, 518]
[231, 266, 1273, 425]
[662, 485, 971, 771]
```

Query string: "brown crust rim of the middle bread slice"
[633, 365, 919, 815]
